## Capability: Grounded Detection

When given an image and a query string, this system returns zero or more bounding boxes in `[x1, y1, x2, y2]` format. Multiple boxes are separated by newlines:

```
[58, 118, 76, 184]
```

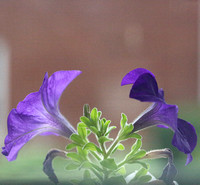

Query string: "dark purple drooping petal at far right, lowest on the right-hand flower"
[172, 119, 197, 164]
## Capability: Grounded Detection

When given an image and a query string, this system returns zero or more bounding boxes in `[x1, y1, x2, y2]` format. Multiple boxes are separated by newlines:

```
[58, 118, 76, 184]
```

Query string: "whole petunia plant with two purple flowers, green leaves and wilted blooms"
[2, 68, 197, 185]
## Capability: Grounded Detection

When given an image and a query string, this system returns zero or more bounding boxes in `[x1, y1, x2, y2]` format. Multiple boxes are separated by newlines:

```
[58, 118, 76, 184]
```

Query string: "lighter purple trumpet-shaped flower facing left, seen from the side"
[2, 70, 81, 161]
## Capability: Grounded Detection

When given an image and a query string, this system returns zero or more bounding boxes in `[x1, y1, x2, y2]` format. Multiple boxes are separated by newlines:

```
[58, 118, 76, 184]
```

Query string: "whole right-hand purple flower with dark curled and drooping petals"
[121, 68, 197, 165]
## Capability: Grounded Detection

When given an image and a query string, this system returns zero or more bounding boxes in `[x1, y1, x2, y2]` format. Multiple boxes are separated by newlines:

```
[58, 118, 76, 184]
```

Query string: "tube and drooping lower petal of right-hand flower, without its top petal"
[133, 103, 197, 165]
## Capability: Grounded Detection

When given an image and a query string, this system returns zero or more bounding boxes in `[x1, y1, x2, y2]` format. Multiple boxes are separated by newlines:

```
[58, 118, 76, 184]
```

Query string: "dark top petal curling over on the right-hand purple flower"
[121, 68, 164, 102]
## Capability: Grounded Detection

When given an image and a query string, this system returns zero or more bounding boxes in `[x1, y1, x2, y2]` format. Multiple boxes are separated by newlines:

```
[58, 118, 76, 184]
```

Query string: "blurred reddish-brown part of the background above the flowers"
[0, 0, 198, 162]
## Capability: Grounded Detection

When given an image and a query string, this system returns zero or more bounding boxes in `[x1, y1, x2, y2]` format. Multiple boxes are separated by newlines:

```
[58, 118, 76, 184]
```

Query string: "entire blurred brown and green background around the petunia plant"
[0, 0, 200, 185]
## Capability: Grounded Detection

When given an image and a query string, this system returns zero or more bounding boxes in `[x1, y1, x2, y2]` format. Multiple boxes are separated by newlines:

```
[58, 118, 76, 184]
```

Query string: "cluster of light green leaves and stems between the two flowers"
[66, 105, 149, 185]
